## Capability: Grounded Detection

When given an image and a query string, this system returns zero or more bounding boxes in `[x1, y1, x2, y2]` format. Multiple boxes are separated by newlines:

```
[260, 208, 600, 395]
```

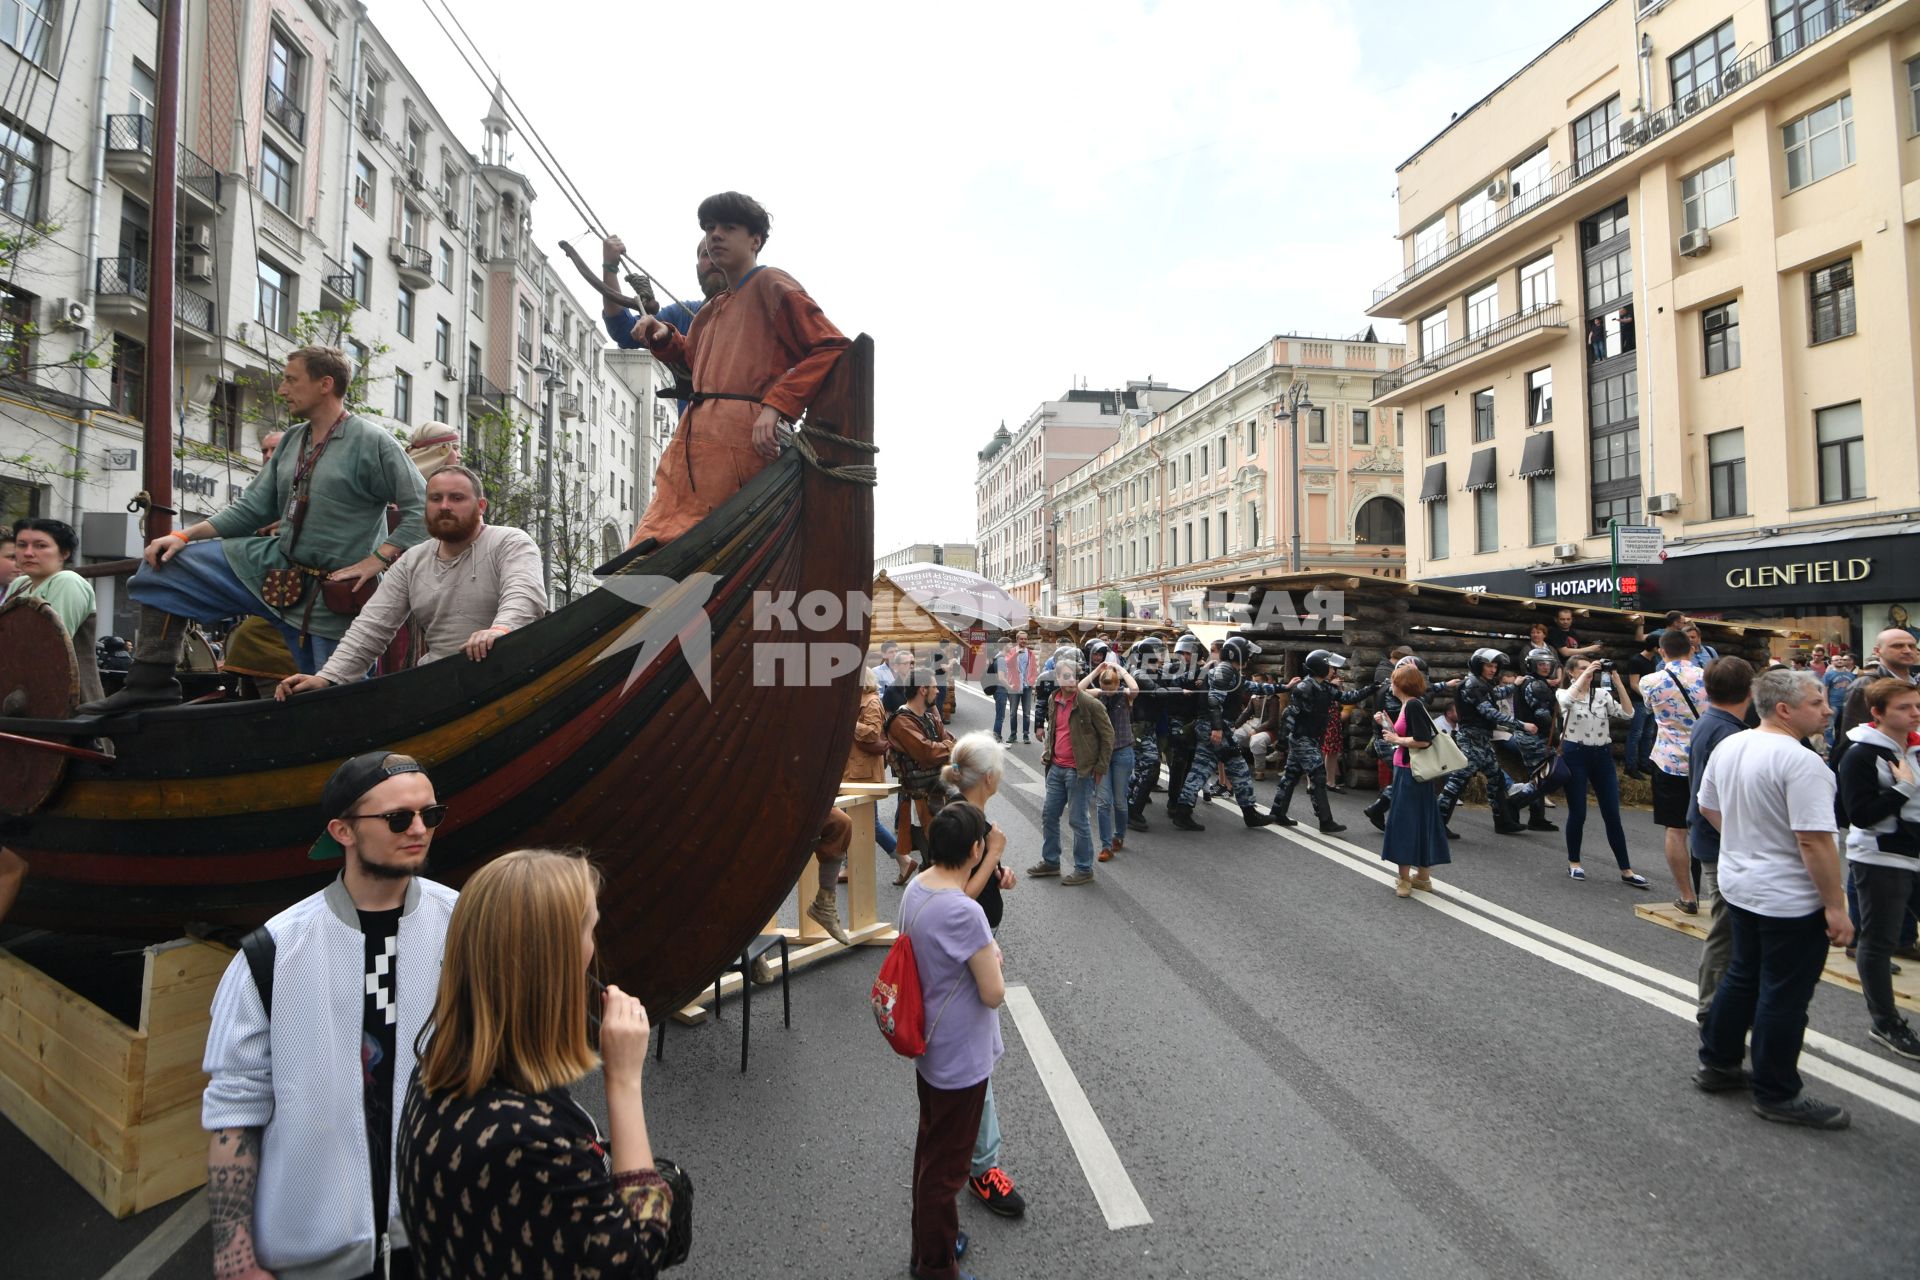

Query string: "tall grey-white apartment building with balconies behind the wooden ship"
[0, 0, 670, 633]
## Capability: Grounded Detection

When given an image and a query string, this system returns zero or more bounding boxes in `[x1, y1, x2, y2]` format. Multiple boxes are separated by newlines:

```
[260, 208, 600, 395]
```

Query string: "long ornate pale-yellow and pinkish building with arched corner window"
[1052, 332, 1405, 620]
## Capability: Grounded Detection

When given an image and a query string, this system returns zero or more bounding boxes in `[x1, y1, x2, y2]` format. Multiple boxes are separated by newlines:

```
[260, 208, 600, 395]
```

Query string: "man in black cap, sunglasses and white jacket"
[200, 750, 457, 1280]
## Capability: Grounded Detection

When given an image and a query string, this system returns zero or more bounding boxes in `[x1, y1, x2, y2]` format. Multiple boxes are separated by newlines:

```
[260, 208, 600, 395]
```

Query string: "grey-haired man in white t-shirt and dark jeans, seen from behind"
[1693, 668, 1853, 1128]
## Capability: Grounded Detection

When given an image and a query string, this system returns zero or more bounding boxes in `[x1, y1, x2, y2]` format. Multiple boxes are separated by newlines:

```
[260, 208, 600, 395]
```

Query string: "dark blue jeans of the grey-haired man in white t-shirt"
[1699, 902, 1828, 1103]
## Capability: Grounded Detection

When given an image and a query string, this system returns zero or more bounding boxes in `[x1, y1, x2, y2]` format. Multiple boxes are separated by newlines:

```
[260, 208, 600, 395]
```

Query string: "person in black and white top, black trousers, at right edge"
[1836, 679, 1920, 1059]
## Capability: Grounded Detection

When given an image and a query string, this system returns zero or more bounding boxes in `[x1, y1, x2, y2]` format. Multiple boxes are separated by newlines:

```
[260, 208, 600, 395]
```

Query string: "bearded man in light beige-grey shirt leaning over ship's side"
[275, 462, 547, 702]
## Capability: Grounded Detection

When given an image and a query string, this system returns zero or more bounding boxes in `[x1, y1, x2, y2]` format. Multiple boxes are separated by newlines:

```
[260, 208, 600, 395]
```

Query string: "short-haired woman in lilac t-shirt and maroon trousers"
[900, 805, 1013, 1280]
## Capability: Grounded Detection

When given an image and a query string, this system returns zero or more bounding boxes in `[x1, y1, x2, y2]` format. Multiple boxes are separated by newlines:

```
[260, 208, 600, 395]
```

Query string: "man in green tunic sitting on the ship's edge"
[84, 347, 426, 714]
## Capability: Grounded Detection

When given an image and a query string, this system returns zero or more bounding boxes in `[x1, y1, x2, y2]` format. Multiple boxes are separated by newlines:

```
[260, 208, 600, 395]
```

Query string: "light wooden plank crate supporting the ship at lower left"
[0, 938, 232, 1219]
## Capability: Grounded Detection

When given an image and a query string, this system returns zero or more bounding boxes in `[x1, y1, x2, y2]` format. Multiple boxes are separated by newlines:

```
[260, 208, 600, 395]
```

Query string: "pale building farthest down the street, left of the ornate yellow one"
[973, 382, 1185, 614]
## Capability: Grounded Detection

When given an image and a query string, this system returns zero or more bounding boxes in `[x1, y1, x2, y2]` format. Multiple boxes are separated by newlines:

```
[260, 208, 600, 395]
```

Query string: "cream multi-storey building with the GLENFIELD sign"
[1371, 0, 1920, 633]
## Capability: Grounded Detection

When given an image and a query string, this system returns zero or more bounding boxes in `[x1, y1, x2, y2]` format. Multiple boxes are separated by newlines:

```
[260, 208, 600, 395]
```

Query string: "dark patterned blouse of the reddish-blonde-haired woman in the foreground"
[396, 1077, 672, 1280]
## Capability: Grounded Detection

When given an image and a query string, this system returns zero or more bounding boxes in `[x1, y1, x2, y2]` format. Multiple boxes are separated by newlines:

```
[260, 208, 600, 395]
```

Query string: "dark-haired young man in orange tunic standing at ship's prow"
[628, 192, 851, 547]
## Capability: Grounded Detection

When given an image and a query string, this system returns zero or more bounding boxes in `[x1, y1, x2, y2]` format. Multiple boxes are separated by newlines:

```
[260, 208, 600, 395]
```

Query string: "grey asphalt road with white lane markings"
[15, 691, 1920, 1280]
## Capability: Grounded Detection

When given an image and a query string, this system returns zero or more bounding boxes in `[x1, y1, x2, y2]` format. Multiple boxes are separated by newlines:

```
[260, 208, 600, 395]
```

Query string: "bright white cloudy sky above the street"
[369, 0, 1599, 553]
